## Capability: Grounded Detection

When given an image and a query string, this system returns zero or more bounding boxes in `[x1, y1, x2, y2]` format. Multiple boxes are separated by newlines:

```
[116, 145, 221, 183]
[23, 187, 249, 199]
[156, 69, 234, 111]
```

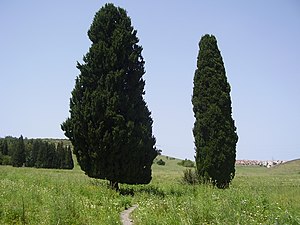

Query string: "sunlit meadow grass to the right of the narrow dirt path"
[134, 161, 300, 224]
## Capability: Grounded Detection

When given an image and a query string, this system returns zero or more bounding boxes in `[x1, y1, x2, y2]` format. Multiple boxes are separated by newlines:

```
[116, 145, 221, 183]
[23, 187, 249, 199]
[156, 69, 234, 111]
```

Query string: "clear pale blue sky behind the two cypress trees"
[0, 0, 300, 159]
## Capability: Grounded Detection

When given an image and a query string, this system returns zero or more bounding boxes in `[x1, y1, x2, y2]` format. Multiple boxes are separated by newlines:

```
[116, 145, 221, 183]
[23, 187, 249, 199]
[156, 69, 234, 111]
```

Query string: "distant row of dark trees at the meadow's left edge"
[0, 135, 74, 169]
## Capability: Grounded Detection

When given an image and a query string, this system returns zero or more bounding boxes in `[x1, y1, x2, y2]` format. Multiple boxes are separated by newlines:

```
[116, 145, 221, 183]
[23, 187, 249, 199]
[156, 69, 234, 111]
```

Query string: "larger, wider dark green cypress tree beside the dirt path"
[62, 4, 157, 187]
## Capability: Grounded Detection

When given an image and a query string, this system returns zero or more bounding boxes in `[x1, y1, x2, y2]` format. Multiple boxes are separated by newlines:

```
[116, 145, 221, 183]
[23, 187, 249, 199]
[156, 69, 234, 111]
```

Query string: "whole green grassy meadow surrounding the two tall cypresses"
[0, 156, 300, 224]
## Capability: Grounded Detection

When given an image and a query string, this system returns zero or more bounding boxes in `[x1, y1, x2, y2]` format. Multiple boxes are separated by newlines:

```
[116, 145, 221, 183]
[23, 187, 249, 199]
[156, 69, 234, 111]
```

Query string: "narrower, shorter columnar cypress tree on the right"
[192, 35, 238, 188]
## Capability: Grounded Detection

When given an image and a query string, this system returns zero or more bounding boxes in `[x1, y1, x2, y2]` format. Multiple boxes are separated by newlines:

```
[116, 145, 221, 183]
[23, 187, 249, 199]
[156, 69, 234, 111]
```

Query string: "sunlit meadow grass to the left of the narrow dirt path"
[0, 166, 124, 224]
